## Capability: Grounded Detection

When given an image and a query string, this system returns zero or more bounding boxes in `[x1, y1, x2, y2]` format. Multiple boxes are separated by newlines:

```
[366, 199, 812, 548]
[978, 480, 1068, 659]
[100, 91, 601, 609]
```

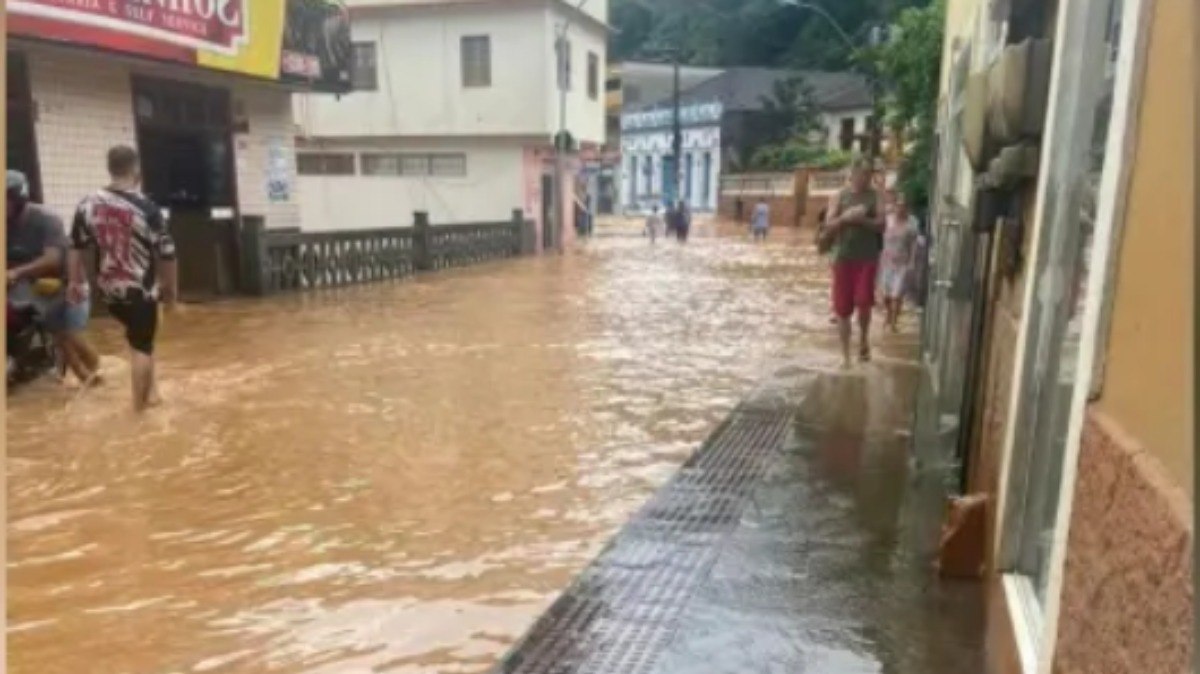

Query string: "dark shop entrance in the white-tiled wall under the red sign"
[133, 78, 239, 301]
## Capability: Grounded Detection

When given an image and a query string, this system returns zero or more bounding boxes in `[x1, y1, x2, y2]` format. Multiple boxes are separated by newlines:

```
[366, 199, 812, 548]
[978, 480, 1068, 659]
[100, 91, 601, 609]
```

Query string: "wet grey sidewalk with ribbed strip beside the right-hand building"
[496, 352, 985, 674]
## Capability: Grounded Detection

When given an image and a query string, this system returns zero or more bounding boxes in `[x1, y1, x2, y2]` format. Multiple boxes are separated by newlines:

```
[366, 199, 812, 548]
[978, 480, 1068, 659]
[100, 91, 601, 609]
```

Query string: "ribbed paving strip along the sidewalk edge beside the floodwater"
[496, 409, 791, 674]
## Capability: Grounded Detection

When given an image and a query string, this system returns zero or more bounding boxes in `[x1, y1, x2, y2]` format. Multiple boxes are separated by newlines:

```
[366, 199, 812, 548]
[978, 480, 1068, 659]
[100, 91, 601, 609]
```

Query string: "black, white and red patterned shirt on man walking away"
[71, 187, 175, 301]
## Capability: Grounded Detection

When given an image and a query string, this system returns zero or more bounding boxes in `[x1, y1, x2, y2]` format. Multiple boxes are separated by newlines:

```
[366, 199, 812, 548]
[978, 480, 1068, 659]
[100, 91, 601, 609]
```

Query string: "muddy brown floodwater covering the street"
[7, 223, 883, 674]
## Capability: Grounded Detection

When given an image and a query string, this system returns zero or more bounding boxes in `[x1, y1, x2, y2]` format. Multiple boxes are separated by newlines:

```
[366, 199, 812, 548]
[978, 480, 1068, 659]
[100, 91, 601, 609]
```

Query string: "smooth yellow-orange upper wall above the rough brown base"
[1099, 0, 1196, 498]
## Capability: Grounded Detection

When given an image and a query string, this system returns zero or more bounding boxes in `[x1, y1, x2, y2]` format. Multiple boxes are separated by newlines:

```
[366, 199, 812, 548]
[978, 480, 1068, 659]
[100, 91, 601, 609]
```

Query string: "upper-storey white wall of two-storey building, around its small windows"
[296, 0, 606, 144]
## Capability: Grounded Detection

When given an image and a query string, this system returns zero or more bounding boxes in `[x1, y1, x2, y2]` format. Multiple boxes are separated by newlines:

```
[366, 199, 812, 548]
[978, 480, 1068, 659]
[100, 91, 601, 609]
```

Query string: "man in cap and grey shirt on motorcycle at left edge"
[5, 170, 100, 386]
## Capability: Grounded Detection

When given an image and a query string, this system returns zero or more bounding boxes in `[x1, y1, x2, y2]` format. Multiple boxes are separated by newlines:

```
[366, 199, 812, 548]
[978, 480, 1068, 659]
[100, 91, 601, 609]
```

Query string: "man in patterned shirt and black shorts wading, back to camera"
[68, 145, 176, 411]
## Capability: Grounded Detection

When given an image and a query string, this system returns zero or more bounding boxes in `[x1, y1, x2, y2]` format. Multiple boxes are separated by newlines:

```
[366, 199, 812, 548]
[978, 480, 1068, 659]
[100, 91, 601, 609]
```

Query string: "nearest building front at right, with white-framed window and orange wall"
[914, 0, 1196, 674]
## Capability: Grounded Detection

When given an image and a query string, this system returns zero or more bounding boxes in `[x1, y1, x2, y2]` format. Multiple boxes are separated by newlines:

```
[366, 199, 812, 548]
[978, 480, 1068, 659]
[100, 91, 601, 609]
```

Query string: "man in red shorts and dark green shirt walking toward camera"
[824, 160, 886, 367]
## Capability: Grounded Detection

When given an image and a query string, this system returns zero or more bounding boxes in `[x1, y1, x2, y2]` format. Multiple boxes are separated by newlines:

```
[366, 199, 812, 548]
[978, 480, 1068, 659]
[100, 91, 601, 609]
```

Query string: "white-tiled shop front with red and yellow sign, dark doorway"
[6, 0, 350, 297]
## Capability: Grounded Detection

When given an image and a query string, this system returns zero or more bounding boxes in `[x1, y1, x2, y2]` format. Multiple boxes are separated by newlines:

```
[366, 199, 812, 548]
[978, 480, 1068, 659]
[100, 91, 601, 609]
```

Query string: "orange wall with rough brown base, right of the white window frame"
[1054, 0, 1196, 674]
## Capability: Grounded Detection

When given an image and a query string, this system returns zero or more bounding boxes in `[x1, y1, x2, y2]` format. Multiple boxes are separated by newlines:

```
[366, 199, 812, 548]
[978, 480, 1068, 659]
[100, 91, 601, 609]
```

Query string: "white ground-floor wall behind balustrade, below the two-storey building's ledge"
[300, 139, 526, 231]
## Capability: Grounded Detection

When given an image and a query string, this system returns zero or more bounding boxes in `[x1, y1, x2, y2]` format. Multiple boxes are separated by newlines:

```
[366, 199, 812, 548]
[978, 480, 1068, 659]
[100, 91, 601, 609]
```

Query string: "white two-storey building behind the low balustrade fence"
[295, 0, 608, 248]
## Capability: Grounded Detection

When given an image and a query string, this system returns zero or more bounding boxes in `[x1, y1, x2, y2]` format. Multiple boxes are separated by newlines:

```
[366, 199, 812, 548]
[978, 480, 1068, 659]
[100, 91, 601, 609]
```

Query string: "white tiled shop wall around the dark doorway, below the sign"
[20, 46, 300, 228]
